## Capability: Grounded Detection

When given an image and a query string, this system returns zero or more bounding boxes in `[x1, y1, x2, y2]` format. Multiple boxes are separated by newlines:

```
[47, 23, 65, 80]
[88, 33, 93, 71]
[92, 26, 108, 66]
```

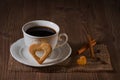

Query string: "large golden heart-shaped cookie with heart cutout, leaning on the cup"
[29, 42, 52, 64]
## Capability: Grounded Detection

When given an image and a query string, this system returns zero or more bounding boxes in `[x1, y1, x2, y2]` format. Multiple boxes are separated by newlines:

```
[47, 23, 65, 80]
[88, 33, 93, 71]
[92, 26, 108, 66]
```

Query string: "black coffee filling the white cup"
[26, 26, 56, 37]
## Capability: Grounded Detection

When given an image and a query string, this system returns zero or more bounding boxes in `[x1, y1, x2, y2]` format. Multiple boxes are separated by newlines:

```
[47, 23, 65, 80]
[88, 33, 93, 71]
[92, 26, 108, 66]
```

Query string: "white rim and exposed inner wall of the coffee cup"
[22, 20, 60, 38]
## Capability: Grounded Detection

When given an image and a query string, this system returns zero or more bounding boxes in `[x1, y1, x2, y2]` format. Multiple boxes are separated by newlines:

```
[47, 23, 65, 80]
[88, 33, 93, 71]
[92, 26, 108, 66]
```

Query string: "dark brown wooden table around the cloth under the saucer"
[0, 0, 120, 80]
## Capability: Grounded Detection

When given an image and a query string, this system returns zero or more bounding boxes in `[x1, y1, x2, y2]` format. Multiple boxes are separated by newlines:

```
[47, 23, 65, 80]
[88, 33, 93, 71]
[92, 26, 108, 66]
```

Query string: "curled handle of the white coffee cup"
[56, 33, 68, 48]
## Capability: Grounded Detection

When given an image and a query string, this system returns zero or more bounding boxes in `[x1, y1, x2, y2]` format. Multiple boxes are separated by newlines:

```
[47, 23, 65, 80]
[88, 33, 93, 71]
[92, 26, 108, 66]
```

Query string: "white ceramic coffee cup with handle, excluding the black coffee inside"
[22, 20, 68, 50]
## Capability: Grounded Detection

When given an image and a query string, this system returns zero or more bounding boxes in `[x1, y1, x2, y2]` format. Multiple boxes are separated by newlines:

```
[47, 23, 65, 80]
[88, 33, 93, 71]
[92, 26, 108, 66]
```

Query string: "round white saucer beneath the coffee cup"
[10, 38, 72, 67]
